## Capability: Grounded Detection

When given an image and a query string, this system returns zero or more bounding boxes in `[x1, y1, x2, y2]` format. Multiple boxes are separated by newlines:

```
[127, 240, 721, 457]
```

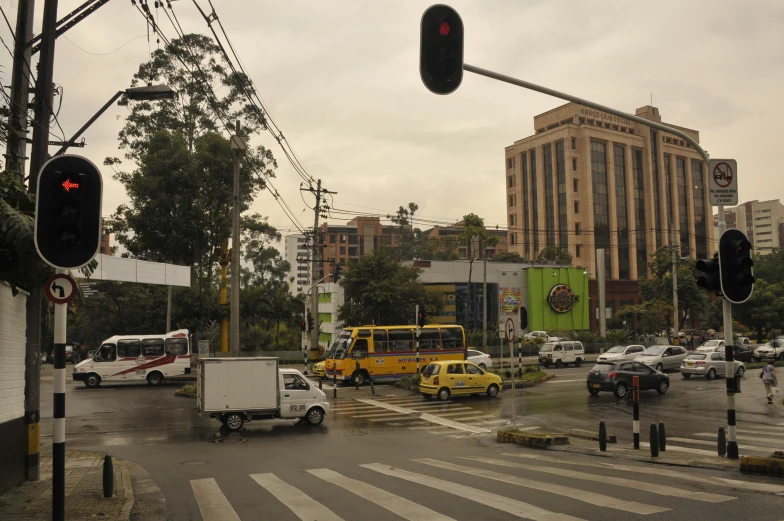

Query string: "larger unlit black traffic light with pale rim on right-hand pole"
[719, 229, 754, 304]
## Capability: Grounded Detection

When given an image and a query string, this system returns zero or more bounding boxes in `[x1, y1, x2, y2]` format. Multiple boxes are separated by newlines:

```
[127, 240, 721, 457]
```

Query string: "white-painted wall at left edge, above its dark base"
[0, 282, 27, 424]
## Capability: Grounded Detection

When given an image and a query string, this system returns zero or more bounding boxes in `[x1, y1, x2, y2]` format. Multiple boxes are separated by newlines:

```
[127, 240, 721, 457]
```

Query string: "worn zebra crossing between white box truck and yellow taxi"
[330, 396, 520, 436]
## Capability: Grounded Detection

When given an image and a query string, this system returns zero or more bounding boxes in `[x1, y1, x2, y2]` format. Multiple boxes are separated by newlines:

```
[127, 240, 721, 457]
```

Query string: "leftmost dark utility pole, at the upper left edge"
[5, 0, 35, 184]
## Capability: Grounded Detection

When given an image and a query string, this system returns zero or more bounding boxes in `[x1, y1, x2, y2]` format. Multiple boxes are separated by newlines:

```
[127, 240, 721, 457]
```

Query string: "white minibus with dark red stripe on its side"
[73, 329, 191, 387]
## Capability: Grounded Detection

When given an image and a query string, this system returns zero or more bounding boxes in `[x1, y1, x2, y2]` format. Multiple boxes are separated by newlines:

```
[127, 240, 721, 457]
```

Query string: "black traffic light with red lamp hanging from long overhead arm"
[419, 4, 463, 94]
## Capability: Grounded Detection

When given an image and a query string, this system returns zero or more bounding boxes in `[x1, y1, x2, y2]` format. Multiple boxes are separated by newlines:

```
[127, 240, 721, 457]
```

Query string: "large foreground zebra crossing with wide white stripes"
[190, 452, 784, 521]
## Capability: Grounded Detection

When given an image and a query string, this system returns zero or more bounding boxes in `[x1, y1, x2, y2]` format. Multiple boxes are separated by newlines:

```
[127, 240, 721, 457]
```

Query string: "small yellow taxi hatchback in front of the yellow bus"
[419, 360, 503, 400]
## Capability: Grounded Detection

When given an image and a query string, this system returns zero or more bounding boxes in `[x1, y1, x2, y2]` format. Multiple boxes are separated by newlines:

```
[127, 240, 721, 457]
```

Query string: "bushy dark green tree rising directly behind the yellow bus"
[338, 246, 444, 326]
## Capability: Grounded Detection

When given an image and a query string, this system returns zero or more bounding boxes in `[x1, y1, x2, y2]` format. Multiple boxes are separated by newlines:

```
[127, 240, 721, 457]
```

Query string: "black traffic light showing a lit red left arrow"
[35, 155, 103, 268]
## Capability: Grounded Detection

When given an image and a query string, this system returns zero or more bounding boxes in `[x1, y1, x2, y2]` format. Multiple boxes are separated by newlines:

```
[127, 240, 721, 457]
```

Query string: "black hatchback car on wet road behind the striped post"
[586, 361, 670, 398]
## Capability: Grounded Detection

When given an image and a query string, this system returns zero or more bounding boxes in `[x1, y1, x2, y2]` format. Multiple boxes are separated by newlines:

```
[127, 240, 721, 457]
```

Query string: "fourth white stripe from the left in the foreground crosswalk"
[360, 463, 583, 521]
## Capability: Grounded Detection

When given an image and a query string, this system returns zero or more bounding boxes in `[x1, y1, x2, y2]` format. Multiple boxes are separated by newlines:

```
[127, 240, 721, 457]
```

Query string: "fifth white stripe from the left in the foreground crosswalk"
[413, 458, 670, 515]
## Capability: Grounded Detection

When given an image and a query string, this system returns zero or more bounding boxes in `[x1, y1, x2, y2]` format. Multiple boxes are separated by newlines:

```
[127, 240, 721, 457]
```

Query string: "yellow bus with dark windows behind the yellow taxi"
[326, 324, 466, 385]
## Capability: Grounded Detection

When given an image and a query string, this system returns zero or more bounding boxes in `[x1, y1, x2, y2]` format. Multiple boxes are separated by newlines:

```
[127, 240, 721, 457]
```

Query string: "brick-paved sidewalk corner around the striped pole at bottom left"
[0, 450, 166, 521]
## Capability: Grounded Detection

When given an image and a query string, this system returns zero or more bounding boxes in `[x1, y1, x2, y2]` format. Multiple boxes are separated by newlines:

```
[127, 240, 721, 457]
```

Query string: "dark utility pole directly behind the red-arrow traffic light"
[20, 0, 57, 481]
